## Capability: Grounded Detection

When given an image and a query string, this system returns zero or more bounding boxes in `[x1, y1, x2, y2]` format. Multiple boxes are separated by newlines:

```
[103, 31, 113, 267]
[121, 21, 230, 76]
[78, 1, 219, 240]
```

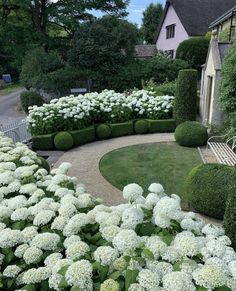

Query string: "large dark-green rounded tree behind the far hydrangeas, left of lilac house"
[69, 16, 138, 74]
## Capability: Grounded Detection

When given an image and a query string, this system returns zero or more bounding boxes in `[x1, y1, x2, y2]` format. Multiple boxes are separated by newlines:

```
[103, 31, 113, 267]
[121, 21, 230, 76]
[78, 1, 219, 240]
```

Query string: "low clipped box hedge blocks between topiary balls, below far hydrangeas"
[32, 119, 176, 150]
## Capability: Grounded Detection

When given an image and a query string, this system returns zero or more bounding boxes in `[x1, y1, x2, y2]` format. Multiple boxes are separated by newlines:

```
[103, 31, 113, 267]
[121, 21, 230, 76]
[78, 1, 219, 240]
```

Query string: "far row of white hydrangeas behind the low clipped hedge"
[28, 90, 174, 135]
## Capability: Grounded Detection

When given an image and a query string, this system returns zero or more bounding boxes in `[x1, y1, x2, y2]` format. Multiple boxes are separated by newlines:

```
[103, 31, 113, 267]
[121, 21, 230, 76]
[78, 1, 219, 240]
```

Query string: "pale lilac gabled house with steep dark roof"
[155, 0, 236, 58]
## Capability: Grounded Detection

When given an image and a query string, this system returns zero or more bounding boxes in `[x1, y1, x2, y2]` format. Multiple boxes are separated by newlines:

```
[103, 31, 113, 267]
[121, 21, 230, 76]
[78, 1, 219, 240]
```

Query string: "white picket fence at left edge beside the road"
[0, 119, 31, 143]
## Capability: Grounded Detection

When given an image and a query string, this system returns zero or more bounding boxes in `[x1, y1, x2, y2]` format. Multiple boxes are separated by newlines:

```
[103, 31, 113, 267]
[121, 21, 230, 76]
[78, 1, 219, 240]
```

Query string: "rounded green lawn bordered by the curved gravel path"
[100, 142, 202, 209]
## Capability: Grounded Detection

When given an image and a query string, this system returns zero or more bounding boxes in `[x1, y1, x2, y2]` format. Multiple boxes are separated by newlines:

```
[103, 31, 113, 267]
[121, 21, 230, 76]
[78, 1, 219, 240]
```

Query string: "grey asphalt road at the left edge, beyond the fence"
[0, 89, 25, 125]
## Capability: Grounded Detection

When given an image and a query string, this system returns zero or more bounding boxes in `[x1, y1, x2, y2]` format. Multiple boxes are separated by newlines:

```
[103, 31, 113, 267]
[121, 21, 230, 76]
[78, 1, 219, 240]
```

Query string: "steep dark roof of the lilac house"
[155, 0, 236, 40]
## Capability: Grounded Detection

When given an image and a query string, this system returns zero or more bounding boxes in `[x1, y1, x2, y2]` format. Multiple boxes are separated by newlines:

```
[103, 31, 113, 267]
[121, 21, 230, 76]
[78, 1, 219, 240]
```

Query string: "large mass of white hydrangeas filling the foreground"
[0, 134, 236, 291]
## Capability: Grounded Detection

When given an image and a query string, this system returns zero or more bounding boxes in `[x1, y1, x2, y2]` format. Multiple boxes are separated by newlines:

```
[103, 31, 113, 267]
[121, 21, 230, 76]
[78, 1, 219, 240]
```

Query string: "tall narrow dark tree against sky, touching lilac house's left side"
[142, 3, 163, 44]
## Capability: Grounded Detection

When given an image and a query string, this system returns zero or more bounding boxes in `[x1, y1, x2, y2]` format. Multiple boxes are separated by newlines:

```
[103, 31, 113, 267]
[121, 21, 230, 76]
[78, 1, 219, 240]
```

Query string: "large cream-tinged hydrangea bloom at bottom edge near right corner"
[193, 265, 227, 289]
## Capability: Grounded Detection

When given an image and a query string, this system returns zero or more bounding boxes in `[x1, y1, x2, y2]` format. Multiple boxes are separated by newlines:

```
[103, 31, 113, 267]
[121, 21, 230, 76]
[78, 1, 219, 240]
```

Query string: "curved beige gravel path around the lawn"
[54, 133, 174, 205]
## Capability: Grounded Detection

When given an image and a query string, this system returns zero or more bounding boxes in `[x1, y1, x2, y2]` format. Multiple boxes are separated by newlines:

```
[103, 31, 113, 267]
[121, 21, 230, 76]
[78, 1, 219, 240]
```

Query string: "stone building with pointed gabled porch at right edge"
[200, 6, 236, 125]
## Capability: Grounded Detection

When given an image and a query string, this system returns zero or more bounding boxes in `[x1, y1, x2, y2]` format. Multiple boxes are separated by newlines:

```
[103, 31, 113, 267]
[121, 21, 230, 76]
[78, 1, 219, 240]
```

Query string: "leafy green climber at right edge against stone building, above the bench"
[220, 44, 236, 113]
